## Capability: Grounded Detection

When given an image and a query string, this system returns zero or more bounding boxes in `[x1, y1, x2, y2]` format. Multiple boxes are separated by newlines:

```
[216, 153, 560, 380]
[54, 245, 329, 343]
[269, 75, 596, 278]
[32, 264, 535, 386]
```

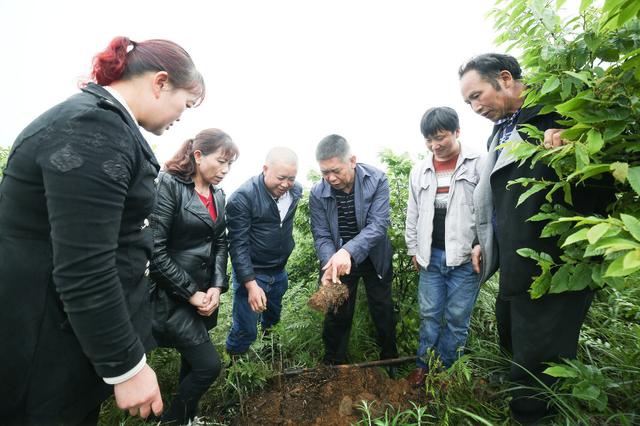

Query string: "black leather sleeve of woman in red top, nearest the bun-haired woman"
[149, 173, 198, 301]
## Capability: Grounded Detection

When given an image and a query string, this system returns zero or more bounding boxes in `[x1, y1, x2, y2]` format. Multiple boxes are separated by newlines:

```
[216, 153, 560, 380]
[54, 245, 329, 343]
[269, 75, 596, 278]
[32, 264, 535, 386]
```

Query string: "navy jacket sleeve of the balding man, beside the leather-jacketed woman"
[227, 193, 256, 284]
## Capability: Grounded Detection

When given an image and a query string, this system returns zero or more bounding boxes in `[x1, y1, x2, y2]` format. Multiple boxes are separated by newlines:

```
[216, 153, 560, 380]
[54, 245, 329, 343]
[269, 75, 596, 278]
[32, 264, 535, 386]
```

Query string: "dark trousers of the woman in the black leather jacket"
[162, 341, 221, 424]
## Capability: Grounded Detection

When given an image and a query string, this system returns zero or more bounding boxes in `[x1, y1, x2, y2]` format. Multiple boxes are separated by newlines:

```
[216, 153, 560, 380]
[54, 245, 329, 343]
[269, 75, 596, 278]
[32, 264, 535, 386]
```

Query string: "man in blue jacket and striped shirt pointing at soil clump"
[309, 135, 397, 364]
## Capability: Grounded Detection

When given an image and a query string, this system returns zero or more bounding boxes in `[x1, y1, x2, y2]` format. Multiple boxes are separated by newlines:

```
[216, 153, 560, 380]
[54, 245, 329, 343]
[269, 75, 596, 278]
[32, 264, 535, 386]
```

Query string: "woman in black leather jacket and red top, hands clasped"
[150, 129, 238, 424]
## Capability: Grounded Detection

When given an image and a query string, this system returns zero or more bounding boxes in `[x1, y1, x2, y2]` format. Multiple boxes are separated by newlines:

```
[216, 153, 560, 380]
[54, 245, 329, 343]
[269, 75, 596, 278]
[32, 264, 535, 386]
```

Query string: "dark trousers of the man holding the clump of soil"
[322, 259, 398, 364]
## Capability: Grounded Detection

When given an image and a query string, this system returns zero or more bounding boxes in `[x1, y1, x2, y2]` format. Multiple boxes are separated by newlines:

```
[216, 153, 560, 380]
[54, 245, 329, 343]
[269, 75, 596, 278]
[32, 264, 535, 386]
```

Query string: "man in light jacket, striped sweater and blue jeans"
[405, 107, 481, 386]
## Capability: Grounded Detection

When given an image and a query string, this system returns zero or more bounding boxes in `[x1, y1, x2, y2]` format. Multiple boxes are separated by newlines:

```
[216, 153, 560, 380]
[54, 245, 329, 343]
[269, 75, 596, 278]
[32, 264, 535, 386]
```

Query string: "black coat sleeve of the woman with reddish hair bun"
[36, 110, 144, 377]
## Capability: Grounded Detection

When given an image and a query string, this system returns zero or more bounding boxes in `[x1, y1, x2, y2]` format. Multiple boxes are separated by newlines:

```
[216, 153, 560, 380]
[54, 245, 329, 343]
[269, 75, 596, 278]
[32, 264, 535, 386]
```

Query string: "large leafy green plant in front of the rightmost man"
[491, 0, 640, 298]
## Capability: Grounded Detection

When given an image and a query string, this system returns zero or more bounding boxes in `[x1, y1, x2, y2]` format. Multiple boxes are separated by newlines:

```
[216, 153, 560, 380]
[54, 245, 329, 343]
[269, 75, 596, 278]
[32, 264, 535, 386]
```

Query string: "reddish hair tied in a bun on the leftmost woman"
[91, 37, 205, 104]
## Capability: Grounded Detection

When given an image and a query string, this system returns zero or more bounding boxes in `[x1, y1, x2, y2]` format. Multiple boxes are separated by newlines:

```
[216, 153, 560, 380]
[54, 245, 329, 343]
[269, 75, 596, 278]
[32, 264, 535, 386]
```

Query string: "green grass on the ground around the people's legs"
[100, 272, 640, 425]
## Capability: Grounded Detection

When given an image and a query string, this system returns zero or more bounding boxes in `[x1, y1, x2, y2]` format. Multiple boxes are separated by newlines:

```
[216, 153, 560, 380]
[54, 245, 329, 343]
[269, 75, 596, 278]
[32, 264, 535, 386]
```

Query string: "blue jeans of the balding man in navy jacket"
[227, 270, 289, 353]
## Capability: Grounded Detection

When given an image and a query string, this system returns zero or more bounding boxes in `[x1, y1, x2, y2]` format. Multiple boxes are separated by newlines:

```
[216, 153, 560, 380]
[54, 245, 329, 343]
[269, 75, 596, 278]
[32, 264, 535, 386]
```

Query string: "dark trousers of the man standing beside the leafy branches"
[496, 290, 594, 421]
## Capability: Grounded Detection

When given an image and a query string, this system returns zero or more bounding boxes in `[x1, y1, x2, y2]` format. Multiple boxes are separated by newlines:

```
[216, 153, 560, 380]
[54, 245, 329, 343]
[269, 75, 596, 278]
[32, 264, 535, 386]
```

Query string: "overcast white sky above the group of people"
[0, 0, 501, 192]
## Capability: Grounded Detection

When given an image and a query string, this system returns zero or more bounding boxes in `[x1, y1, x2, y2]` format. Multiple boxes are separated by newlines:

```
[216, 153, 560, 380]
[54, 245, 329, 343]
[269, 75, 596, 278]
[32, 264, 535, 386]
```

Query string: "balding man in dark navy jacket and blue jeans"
[227, 147, 302, 354]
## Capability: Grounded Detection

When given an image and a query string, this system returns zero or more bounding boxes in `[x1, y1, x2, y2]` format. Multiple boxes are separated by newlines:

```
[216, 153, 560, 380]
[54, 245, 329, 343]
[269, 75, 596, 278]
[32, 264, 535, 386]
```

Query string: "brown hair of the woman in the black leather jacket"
[164, 129, 240, 178]
